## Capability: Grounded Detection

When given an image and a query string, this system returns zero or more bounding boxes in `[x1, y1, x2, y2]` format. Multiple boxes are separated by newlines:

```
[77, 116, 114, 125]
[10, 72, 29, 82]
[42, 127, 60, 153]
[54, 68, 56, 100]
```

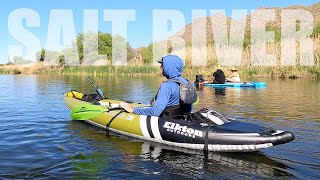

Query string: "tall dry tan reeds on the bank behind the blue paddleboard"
[172, 37, 320, 78]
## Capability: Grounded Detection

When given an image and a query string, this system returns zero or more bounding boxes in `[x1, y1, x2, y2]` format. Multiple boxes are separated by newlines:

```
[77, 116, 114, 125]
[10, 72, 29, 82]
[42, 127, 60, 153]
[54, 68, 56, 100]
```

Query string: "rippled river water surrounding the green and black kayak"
[0, 75, 320, 179]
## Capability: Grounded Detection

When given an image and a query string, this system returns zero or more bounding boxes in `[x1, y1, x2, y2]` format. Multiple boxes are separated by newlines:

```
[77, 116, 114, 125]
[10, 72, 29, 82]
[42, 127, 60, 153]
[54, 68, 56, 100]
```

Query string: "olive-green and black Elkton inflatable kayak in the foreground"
[64, 92, 294, 151]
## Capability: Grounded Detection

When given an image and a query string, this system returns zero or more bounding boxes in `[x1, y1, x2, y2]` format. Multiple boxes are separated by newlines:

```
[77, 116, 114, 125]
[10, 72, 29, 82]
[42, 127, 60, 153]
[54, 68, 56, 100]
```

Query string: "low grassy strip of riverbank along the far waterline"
[0, 63, 320, 78]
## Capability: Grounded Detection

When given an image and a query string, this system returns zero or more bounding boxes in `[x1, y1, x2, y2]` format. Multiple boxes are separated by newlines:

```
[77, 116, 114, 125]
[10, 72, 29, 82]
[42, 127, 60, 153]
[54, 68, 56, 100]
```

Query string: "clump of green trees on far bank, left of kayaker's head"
[36, 32, 134, 66]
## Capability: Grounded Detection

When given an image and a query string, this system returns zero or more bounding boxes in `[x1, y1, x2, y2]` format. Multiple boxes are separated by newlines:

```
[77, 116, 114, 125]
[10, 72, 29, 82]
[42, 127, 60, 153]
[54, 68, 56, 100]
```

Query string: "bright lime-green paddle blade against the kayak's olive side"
[71, 104, 106, 120]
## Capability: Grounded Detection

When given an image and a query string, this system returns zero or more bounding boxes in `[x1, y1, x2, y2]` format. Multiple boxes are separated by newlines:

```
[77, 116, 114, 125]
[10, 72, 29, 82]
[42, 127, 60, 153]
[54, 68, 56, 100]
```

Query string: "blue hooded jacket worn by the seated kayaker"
[133, 55, 187, 116]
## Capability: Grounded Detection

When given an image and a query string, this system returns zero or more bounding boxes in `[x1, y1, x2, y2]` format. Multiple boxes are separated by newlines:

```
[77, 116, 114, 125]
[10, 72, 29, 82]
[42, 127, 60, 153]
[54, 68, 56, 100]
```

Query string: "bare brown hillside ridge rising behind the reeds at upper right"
[169, 2, 320, 44]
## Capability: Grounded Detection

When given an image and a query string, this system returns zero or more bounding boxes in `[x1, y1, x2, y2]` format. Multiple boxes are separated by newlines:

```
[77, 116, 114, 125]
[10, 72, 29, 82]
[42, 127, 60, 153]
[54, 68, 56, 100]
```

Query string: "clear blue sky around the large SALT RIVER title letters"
[0, 0, 318, 64]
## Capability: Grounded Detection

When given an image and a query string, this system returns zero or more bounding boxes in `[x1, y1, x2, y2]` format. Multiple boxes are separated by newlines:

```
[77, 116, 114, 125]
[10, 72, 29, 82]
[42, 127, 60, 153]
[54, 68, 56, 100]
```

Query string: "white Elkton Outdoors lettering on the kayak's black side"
[163, 121, 202, 138]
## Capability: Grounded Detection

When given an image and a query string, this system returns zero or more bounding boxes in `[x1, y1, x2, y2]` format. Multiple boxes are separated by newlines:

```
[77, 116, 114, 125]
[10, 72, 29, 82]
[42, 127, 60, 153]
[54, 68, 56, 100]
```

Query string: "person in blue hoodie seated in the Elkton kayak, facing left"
[120, 55, 192, 117]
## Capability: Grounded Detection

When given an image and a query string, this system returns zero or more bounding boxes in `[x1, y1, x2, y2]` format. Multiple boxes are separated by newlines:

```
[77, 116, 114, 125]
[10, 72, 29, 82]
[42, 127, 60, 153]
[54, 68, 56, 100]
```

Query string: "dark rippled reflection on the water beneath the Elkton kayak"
[69, 121, 293, 179]
